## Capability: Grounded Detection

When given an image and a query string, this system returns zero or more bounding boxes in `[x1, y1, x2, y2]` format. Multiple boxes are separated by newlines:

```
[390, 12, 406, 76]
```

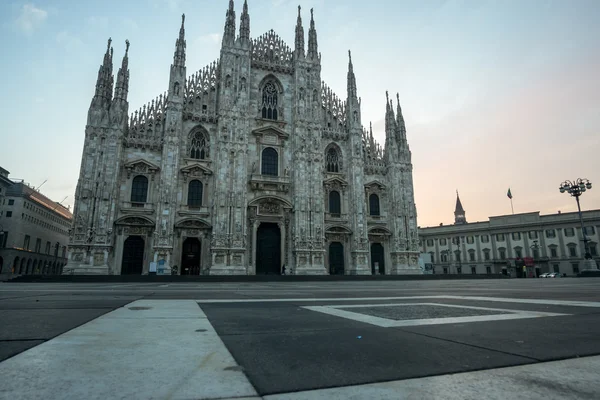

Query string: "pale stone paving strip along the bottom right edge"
[264, 356, 600, 400]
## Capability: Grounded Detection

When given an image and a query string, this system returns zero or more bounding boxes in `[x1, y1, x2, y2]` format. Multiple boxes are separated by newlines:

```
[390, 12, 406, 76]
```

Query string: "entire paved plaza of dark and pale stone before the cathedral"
[0, 278, 600, 400]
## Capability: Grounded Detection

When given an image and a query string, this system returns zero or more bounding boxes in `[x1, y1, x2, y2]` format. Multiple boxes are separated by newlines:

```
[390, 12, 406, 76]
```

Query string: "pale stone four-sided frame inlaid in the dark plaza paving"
[302, 303, 569, 328]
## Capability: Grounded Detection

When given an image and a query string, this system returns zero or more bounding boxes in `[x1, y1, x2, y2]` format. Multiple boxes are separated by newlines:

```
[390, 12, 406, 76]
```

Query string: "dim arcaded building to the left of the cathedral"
[0, 177, 73, 275]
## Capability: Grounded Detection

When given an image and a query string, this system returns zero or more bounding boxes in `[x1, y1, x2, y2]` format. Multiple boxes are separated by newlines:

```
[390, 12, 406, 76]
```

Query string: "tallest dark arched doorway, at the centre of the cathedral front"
[256, 222, 281, 275]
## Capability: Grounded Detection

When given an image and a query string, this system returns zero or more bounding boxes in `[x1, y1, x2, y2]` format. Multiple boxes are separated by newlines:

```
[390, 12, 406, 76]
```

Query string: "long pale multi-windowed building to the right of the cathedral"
[419, 197, 600, 277]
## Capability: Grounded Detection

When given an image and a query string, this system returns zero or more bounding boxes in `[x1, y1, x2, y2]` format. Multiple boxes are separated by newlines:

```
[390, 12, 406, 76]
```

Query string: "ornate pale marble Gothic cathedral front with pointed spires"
[64, 1, 420, 275]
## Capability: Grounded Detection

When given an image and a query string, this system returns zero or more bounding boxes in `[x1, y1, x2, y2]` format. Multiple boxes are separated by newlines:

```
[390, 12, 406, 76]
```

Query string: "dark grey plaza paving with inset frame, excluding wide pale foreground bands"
[0, 278, 600, 396]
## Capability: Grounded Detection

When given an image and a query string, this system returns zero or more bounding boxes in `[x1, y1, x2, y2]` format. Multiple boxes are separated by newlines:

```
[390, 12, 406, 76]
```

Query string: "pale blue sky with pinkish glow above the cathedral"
[0, 0, 600, 226]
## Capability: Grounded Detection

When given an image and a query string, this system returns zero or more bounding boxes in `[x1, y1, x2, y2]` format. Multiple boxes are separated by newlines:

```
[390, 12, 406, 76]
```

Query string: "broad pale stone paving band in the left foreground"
[0, 300, 257, 400]
